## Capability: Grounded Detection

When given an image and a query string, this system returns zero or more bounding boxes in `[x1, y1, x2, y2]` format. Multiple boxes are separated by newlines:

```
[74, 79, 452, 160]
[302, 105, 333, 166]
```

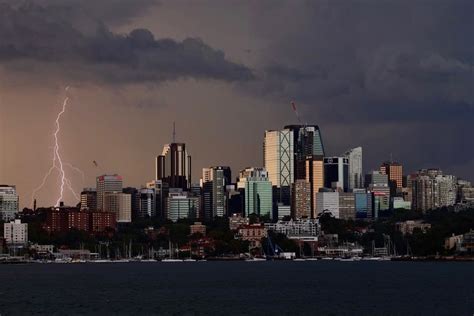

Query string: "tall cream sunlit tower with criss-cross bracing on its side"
[263, 129, 295, 205]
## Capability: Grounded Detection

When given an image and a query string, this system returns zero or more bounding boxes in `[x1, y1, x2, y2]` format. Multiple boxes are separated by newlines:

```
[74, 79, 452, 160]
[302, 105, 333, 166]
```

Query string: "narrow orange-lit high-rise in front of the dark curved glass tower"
[305, 155, 324, 218]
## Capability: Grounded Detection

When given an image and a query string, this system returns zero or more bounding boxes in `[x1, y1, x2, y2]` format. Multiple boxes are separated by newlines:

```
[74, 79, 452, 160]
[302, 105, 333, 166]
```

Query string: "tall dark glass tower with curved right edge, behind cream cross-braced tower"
[285, 125, 325, 180]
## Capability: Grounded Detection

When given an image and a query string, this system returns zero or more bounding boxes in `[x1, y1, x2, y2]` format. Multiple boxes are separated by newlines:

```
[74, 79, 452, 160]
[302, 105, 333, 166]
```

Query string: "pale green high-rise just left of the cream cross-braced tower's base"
[240, 170, 273, 219]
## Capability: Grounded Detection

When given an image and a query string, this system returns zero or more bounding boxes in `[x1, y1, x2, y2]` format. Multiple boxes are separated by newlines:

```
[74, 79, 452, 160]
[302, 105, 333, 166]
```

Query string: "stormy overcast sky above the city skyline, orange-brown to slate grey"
[0, 0, 474, 206]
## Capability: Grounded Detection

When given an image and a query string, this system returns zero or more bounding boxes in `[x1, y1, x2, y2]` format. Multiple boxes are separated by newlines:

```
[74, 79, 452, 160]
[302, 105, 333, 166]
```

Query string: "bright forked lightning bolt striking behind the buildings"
[31, 87, 84, 207]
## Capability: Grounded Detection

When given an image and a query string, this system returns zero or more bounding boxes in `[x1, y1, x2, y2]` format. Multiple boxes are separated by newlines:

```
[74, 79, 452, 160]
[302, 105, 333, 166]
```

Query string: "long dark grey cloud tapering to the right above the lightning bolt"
[0, 1, 252, 83]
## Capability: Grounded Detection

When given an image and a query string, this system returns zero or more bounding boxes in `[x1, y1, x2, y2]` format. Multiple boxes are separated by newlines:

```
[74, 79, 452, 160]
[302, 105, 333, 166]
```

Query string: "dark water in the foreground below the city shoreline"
[0, 261, 474, 316]
